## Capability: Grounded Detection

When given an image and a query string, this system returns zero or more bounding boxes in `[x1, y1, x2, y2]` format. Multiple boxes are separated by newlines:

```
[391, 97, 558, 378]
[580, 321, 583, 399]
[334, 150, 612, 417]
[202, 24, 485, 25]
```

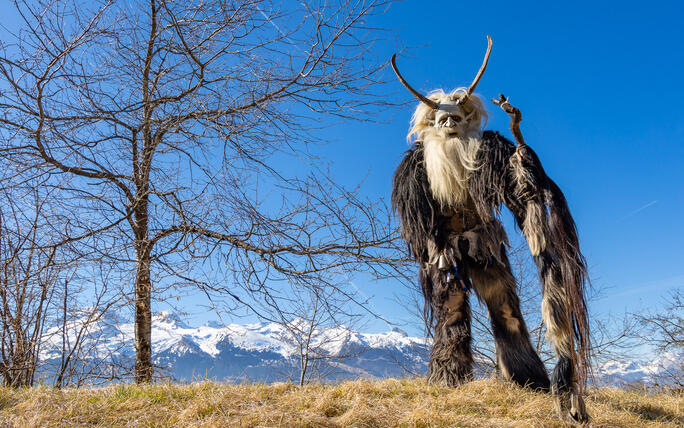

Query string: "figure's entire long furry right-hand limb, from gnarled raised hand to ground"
[470, 95, 590, 422]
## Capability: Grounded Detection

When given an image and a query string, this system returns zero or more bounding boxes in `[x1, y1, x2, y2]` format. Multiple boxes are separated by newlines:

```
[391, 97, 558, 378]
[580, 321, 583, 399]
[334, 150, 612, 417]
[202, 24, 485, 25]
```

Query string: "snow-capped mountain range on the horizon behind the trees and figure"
[41, 311, 684, 385]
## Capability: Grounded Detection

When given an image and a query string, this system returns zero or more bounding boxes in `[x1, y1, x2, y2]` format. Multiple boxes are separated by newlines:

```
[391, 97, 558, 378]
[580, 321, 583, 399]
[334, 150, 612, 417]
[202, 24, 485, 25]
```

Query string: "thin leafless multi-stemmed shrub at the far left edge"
[0, 188, 62, 387]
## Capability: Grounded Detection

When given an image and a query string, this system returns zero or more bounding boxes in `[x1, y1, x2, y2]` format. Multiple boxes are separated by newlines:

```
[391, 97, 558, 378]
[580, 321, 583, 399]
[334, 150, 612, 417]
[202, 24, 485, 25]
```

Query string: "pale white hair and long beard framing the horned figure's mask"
[407, 88, 487, 209]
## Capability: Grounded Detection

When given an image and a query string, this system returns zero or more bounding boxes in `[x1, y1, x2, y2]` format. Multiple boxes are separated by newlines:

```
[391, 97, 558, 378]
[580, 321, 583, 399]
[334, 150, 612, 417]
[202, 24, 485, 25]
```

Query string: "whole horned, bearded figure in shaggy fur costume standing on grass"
[391, 36, 589, 423]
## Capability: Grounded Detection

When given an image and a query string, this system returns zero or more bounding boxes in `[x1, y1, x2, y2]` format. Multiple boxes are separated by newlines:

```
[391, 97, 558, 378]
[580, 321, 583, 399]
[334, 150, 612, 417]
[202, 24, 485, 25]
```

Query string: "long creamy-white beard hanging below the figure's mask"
[423, 130, 481, 209]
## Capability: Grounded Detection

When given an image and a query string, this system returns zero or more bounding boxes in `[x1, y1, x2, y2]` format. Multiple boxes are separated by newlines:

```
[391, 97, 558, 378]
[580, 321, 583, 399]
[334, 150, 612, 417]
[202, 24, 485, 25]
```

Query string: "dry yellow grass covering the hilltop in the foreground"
[0, 379, 684, 427]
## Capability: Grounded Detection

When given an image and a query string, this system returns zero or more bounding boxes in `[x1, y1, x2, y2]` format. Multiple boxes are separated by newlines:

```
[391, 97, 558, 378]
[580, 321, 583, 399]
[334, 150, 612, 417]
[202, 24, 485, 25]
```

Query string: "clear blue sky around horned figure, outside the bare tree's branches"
[0, 0, 684, 340]
